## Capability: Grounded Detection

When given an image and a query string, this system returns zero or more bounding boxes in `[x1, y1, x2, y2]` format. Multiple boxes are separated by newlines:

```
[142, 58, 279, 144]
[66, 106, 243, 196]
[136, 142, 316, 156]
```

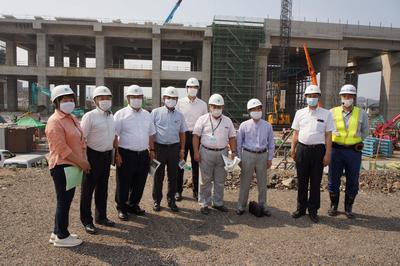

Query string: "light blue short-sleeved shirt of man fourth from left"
[151, 106, 187, 144]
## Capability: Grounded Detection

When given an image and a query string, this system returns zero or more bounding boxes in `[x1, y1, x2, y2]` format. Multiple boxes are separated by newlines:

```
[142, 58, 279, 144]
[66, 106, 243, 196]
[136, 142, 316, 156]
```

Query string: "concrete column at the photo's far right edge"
[379, 53, 400, 119]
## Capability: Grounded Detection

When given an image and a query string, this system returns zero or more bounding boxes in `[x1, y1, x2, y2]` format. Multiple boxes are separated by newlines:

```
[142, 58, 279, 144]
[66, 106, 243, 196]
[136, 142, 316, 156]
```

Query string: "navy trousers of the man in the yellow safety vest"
[328, 148, 362, 197]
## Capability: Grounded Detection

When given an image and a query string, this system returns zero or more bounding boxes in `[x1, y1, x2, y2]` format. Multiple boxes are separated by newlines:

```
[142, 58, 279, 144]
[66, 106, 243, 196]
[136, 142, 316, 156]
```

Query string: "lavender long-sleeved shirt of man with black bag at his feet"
[236, 119, 275, 160]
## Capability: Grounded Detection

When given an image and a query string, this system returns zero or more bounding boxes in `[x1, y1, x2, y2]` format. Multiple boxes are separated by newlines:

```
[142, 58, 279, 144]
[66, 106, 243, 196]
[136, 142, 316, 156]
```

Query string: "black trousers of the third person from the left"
[115, 148, 150, 212]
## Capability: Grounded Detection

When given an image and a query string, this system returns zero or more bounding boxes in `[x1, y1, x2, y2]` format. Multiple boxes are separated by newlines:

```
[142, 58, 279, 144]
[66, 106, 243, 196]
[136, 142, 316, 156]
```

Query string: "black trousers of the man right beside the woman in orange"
[80, 147, 111, 225]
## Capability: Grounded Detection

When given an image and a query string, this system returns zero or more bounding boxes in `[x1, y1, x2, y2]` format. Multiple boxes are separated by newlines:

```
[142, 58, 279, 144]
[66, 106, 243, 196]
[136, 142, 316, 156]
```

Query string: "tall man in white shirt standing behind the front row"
[175, 78, 208, 201]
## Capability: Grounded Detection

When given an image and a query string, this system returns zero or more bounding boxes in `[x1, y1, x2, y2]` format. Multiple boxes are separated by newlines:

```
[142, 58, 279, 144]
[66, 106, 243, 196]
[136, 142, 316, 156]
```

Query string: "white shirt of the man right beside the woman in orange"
[81, 108, 115, 152]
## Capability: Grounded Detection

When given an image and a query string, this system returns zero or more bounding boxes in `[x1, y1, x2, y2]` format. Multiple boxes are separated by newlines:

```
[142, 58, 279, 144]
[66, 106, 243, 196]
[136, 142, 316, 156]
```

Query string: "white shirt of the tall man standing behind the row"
[176, 97, 208, 131]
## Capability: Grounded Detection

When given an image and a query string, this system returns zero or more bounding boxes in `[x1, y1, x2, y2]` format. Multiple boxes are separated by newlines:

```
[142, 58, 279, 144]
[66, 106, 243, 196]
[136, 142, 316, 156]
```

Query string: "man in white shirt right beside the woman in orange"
[80, 86, 115, 234]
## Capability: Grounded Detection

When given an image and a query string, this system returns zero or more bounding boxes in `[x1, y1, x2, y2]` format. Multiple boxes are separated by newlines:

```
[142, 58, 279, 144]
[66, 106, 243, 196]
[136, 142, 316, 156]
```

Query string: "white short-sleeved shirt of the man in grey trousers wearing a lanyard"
[193, 113, 236, 149]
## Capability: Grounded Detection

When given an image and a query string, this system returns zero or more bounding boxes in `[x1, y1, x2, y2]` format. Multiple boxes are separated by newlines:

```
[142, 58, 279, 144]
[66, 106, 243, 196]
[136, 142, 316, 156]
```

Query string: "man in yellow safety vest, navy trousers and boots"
[328, 84, 369, 218]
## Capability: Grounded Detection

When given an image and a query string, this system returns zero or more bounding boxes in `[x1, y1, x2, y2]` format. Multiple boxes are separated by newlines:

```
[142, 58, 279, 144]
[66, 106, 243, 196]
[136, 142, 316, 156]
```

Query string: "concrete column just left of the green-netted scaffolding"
[201, 28, 212, 102]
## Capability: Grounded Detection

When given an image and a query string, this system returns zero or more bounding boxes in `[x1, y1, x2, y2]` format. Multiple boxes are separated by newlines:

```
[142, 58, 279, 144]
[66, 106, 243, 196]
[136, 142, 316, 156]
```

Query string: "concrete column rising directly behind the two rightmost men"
[318, 50, 348, 109]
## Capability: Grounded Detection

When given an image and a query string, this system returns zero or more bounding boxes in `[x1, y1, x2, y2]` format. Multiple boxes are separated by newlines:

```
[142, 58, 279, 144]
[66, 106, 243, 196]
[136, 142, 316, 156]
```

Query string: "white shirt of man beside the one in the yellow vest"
[292, 107, 335, 145]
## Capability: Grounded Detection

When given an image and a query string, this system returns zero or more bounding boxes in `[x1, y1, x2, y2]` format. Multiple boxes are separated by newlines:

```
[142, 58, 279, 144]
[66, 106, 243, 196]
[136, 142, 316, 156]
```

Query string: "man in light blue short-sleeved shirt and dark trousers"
[151, 86, 187, 212]
